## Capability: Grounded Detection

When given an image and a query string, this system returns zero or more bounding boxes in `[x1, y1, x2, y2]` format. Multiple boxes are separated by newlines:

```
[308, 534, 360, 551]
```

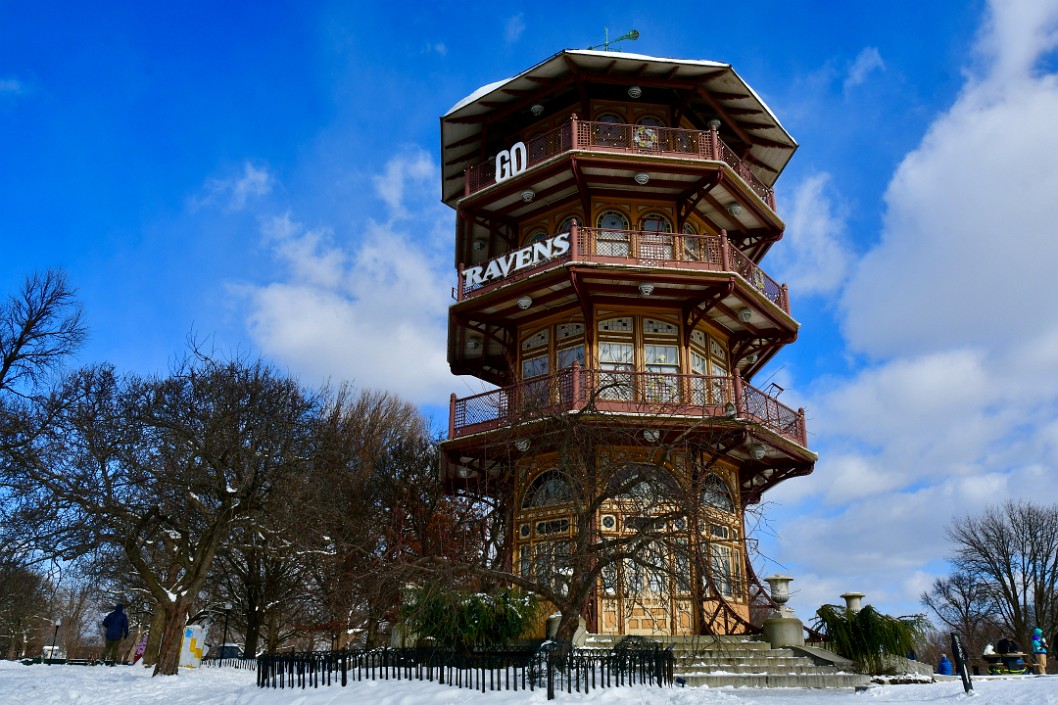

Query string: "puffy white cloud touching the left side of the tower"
[235, 151, 455, 404]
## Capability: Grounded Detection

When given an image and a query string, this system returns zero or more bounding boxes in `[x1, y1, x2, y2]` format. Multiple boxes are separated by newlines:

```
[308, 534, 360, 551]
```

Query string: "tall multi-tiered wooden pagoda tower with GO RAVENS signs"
[433, 50, 816, 635]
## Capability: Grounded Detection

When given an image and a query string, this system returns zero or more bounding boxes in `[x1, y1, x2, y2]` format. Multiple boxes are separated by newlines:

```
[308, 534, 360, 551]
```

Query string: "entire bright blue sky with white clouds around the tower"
[6, 0, 1058, 617]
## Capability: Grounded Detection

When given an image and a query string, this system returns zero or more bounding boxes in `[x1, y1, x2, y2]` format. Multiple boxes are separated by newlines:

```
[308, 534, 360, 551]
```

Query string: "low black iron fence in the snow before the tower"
[257, 643, 674, 700]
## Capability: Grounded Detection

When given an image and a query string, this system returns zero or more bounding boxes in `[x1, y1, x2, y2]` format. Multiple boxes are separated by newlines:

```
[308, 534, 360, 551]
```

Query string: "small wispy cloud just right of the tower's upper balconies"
[768, 174, 852, 295]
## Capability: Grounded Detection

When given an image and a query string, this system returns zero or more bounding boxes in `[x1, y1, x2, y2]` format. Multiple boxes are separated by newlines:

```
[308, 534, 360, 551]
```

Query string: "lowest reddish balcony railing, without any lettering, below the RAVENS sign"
[449, 364, 807, 447]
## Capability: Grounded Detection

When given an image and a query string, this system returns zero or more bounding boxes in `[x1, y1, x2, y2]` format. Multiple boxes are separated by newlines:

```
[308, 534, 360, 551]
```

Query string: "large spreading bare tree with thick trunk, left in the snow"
[8, 356, 315, 674]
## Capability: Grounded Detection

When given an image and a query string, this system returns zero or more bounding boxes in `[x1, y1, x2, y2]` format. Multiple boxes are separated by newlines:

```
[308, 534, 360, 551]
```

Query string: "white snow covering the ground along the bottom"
[0, 662, 1058, 705]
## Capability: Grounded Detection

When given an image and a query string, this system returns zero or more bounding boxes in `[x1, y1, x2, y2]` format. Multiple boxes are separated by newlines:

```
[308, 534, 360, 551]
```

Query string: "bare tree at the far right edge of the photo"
[948, 502, 1058, 644]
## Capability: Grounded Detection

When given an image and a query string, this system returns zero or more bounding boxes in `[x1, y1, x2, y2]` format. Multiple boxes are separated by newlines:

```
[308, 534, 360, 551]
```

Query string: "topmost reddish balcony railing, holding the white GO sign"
[464, 115, 776, 211]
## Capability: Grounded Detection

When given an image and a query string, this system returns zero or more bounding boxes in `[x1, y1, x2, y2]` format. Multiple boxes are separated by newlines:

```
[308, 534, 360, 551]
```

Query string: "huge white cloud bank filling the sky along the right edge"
[768, 0, 1058, 613]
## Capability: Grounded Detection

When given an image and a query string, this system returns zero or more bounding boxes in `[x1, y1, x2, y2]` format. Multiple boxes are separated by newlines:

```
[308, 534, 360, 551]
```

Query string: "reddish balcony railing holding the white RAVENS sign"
[456, 224, 790, 313]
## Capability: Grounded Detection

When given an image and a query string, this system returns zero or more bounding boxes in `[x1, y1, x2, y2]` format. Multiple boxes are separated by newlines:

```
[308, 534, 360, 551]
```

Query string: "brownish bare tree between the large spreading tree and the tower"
[299, 390, 474, 646]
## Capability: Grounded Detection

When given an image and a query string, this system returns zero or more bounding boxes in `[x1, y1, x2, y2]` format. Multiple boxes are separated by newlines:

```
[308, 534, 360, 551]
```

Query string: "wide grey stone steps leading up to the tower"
[584, 634, 871, 688]
